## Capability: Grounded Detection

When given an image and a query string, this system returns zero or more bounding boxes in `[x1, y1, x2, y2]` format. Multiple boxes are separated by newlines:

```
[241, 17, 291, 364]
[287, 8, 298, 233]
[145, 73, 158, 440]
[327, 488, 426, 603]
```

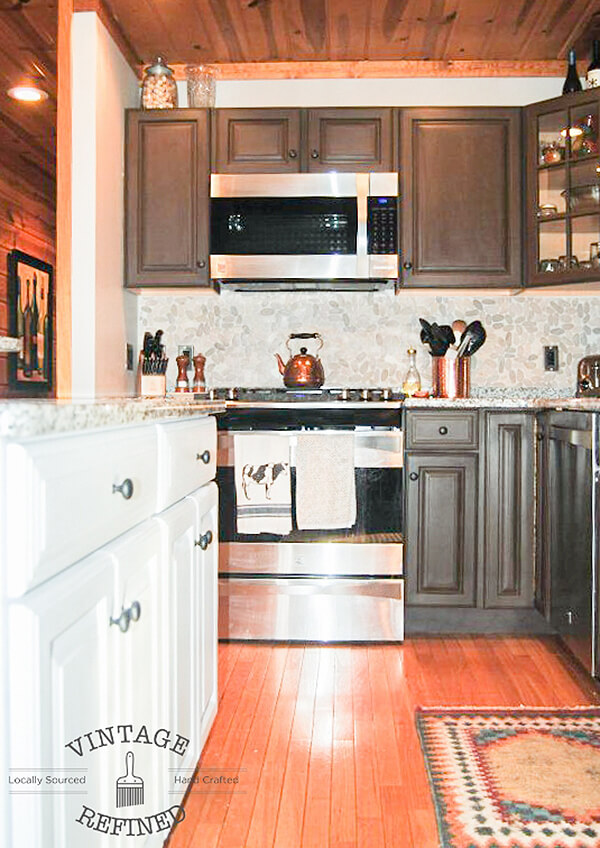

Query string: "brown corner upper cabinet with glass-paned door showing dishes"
[525, 90, 600, 286]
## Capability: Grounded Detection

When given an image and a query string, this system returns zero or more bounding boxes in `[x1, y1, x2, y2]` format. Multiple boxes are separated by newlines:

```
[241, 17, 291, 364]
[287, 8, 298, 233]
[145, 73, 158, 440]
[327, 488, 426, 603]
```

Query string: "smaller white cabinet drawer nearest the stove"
[156, 416, 217, 512]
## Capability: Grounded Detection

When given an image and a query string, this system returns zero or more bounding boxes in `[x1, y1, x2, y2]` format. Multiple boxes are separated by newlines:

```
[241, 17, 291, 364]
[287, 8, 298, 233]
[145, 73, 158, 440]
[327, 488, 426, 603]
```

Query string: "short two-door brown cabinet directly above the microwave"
[213, 108, 395, 174]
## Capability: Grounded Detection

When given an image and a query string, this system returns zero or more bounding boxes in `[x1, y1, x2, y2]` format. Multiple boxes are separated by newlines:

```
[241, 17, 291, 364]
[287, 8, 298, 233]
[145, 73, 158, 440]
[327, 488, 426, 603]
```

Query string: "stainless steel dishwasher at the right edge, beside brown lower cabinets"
[546, 411, 600, 675]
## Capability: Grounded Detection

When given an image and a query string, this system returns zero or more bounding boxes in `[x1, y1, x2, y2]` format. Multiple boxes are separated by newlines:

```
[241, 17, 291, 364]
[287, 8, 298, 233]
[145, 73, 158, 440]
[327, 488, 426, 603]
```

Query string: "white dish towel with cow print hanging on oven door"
[234, 433, 292, 536]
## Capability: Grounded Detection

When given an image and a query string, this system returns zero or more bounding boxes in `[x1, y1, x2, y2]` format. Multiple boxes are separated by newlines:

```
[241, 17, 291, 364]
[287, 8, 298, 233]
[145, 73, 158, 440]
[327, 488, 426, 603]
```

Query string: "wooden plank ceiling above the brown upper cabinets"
[98, 0, 600, 69]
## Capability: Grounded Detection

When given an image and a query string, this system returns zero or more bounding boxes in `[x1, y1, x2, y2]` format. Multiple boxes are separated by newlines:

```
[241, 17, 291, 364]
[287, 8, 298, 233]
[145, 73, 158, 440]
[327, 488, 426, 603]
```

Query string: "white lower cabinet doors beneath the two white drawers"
[8, 483, 218, 848]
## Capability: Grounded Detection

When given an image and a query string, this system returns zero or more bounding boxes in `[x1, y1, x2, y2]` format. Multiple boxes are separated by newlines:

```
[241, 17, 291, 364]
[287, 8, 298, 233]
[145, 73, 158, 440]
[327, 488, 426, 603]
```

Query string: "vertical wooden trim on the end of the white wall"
[55, 0, 73, 398]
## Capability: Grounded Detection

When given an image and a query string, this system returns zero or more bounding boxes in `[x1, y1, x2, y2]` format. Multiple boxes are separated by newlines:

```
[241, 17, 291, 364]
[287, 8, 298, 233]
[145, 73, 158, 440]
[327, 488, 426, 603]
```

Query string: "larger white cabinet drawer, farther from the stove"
[6, 426, 157, 597]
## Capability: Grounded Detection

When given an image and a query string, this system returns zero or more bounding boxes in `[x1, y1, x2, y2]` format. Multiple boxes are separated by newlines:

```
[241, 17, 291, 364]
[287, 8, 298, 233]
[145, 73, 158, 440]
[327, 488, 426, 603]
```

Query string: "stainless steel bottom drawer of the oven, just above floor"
[219, 577, 404, 642]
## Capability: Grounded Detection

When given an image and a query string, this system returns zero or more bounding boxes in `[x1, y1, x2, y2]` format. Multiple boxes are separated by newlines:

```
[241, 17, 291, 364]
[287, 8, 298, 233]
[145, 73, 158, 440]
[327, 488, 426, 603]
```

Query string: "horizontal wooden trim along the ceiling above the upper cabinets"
[168, 58, 565, 80]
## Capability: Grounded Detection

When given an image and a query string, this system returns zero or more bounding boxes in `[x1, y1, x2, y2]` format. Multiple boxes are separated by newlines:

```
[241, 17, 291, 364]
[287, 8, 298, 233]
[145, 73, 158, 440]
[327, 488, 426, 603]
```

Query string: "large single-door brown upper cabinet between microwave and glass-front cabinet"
[400, 108, 522, 288]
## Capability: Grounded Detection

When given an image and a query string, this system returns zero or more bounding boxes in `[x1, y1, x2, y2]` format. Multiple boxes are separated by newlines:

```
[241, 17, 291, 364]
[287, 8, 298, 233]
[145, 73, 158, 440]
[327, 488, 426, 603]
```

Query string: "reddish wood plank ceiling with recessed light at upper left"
[0, 0, 57, 193]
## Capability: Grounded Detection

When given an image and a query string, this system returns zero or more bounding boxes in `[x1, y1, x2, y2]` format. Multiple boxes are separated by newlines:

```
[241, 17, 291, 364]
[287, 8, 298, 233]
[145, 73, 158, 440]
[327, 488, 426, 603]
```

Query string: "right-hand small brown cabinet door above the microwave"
[307, 109, 394, 171]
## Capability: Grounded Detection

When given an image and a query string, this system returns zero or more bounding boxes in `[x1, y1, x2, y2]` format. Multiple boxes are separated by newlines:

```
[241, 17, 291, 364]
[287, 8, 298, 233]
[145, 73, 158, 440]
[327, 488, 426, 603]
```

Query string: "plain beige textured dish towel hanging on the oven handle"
[296, 432, 356, 530]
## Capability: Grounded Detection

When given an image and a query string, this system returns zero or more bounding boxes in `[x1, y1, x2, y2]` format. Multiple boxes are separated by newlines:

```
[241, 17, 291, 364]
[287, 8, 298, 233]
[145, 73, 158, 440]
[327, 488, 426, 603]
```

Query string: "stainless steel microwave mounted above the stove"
[210, 172, 398, 290]
